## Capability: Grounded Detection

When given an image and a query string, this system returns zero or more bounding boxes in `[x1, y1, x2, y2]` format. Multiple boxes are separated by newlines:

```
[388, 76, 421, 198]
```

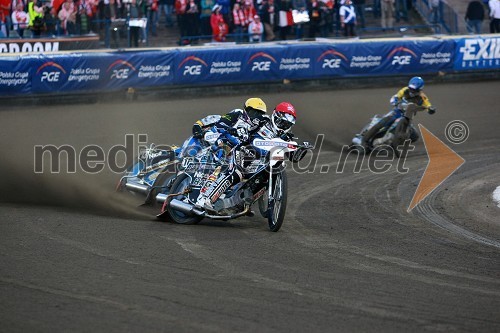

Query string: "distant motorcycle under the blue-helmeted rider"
[350, 101, 427, 157]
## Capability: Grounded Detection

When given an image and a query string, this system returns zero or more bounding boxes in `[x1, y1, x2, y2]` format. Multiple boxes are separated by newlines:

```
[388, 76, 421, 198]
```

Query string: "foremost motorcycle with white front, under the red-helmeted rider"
[157, 131, 313, 232]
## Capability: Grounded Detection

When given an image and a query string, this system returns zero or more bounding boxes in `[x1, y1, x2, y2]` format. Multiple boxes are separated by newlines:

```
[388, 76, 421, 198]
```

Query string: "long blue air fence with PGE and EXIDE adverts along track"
[0, 35, 500, 97]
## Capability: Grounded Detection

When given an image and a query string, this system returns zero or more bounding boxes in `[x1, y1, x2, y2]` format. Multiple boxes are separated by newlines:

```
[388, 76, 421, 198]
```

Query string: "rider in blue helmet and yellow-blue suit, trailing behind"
[361, 76, 436, 147]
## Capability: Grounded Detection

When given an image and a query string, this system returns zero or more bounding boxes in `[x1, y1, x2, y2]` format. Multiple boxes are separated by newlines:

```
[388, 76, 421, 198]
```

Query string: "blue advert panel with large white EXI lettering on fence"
[454, 37, 500, 70]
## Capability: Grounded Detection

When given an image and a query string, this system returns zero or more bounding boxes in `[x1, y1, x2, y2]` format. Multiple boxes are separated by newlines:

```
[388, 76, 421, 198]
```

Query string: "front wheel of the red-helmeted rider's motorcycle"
[267, 170, 288, 232]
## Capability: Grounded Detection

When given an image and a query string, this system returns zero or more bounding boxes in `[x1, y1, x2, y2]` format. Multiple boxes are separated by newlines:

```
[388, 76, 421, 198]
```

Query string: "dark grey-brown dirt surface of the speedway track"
[0, 81, 500, 332]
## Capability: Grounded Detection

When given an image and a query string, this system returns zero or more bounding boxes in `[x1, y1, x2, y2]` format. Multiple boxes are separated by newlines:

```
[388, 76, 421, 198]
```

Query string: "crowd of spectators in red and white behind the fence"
[0, 0, 500, 46]
